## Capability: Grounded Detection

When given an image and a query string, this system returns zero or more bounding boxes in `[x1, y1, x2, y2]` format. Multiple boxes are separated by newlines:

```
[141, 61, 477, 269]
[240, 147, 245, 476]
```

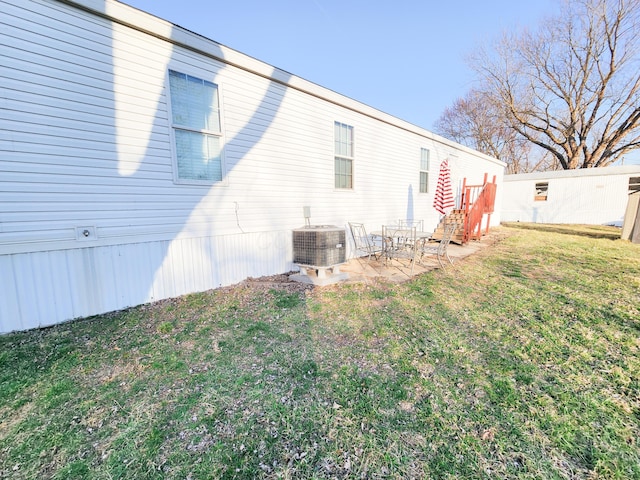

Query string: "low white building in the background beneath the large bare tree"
[502, 165, 640, 226]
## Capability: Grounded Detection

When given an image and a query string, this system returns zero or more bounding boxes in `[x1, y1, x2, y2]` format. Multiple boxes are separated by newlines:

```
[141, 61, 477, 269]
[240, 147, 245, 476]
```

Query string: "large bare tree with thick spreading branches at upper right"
[471, 0, 640, 169]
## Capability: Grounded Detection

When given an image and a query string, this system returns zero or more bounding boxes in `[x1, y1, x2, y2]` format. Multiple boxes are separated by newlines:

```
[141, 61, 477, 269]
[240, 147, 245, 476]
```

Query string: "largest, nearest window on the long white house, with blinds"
[169, 70, 223, 184]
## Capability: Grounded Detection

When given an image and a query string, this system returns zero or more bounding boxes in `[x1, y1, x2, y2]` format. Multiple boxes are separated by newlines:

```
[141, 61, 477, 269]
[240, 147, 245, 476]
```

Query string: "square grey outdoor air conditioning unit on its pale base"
[293, 225, 348, 285]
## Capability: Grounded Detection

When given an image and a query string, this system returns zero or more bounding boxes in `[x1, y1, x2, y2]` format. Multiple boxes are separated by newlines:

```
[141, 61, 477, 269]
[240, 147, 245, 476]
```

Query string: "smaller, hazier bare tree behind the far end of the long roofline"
[435, 90, 553, 173]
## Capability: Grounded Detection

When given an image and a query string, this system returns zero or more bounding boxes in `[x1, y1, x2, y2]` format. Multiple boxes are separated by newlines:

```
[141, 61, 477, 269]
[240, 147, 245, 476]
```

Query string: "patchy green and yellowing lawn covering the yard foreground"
[0, 224, 640, 479]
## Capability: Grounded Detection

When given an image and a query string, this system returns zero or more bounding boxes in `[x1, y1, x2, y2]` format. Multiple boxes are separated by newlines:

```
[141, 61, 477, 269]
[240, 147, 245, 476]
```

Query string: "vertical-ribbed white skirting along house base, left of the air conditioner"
[0, 231, 293, 333]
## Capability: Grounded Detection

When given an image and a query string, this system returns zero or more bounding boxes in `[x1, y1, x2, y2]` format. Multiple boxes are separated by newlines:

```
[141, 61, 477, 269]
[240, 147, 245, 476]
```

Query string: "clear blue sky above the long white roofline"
[124, 0, 560, 130]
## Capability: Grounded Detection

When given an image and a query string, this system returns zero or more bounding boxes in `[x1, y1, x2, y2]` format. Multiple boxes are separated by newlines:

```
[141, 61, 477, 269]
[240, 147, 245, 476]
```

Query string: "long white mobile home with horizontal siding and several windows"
[0, 0, 504, 332]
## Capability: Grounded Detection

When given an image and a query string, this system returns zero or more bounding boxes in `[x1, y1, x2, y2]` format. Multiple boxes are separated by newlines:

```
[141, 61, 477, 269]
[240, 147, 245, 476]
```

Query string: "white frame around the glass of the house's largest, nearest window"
[165, 65, 228, 187]
